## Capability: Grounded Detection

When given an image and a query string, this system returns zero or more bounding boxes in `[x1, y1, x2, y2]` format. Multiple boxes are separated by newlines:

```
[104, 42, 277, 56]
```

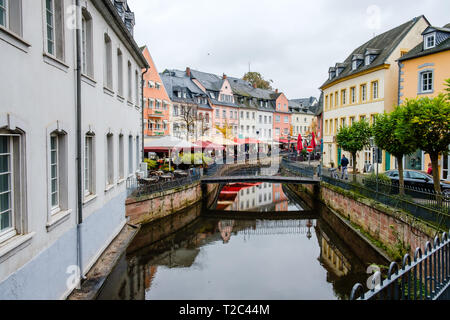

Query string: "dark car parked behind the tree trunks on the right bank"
[385, 170, 450, 199]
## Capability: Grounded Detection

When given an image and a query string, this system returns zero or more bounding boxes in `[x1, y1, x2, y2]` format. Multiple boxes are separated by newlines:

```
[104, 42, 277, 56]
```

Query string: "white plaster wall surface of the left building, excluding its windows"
[0, 0, 142, 299]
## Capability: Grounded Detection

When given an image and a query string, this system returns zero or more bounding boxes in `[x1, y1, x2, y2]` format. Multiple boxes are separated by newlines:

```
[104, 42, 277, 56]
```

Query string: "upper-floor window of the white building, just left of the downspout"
[45, 0, 64, 60]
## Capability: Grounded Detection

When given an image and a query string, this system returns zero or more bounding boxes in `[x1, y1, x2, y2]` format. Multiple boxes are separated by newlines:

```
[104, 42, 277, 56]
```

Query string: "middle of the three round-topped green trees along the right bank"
[372, 107, 417, 195]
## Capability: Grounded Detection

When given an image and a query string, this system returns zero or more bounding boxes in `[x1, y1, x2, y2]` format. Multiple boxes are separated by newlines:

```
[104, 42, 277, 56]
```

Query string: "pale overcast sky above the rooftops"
[128, 0, 450, 99]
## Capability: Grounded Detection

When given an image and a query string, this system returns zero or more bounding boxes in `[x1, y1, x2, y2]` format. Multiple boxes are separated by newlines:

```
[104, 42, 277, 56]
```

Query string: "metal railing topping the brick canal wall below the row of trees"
[322, 170, 450, 229]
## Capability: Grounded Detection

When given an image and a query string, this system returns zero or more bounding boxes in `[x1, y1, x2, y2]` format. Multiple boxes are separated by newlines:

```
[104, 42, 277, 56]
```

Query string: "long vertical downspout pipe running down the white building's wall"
[75, 0, 84, 287]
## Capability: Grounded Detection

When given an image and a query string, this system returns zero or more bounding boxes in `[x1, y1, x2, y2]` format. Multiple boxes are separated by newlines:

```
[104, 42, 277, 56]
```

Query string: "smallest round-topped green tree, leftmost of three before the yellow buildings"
[336, 120, 372, 182]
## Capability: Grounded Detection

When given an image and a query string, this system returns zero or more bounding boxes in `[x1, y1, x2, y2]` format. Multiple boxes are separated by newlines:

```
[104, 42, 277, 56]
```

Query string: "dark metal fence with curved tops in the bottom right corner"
[350, 233, 450, 300]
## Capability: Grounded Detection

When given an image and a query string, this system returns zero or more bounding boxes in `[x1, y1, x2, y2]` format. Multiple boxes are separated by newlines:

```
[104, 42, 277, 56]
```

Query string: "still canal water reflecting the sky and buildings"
[98, 183, 386, 300]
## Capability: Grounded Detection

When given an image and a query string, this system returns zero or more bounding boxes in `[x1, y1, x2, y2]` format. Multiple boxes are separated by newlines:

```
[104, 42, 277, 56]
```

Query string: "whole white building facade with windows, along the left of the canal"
[0, 0, 146, 299]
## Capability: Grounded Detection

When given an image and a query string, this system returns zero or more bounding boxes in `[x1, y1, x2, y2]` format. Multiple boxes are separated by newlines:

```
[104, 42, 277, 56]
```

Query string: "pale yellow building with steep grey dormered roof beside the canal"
[320, 16, 429, 172]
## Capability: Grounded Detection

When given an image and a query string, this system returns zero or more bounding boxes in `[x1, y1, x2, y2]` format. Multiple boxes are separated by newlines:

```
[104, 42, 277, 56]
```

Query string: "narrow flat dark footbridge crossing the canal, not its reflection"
[201, 175, 320, 185]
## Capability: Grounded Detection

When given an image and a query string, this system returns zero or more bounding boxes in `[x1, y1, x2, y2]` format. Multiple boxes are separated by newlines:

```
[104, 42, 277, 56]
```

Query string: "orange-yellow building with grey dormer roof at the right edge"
[399, 23, 450, 180]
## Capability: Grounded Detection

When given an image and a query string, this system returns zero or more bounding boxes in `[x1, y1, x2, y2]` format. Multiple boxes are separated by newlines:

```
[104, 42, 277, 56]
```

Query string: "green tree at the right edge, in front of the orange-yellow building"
[404, 93, 450, 194]
